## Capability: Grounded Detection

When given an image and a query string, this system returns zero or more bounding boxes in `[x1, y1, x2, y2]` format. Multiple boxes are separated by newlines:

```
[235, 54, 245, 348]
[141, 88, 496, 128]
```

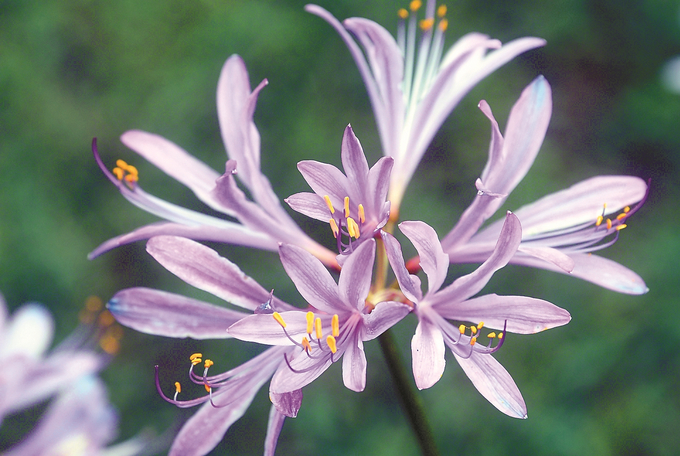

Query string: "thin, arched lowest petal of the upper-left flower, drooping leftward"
[87, 218, 279, 260]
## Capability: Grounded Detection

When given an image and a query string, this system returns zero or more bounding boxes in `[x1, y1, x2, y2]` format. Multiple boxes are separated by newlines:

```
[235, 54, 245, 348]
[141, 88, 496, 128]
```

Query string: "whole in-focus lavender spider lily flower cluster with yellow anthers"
[91, 0, 647, 455]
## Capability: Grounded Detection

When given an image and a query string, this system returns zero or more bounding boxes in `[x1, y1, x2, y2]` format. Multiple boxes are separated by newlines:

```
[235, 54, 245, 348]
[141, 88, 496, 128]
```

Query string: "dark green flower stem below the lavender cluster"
[378, 330, 439, 456]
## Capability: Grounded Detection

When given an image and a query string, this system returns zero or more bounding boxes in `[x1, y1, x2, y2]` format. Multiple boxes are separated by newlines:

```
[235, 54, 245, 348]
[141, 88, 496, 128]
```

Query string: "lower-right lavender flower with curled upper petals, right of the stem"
[382, 213, 571, 418]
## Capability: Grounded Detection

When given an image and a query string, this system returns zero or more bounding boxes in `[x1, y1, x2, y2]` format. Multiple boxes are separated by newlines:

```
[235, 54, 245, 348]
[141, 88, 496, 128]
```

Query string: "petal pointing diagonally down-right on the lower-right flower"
[454, 352, 527, 419]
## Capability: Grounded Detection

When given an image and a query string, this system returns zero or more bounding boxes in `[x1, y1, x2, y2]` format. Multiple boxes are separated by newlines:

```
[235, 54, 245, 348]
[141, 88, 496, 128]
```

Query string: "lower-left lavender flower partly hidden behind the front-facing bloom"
[108, 236, 302, 455]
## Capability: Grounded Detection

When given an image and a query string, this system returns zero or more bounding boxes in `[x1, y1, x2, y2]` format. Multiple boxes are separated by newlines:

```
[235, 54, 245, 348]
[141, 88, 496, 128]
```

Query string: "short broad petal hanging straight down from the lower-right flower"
[411, 316, 446, 389]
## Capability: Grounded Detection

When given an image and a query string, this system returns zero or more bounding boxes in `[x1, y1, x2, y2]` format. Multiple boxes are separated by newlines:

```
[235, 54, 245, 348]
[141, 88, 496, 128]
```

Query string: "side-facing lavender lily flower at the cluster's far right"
[442, 76, 648, 294]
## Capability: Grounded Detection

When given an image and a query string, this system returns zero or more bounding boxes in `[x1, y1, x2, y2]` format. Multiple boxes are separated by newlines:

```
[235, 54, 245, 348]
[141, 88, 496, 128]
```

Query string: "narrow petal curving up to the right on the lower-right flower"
[436, 212, 522, 306]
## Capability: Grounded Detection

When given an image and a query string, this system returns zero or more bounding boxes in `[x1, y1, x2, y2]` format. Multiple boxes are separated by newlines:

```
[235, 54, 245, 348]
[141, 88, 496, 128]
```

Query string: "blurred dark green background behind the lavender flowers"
[0, 0, 680, 456]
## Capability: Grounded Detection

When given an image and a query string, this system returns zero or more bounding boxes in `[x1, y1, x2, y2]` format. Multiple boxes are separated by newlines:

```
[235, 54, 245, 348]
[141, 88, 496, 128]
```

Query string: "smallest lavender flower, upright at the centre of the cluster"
[285, 125, 394, 253]
